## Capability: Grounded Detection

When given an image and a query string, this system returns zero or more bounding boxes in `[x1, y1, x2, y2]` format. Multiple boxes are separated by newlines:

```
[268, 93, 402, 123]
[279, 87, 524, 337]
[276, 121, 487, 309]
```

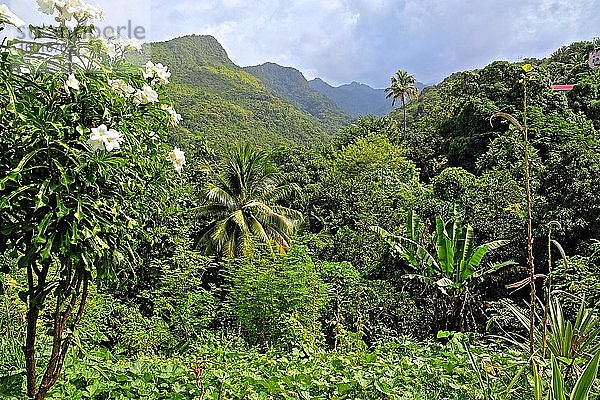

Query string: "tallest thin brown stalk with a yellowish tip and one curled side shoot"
[490, 64, 536, 356]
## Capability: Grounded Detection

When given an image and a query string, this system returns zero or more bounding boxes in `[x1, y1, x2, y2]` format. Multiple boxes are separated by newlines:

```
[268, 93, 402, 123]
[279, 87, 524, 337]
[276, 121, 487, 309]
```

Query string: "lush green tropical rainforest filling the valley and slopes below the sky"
[0, 1, 600, 400]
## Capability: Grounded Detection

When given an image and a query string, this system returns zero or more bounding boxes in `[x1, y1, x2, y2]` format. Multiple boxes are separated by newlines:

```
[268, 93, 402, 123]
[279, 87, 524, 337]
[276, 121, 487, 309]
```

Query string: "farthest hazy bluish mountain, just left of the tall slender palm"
[308, 78, 424, 117]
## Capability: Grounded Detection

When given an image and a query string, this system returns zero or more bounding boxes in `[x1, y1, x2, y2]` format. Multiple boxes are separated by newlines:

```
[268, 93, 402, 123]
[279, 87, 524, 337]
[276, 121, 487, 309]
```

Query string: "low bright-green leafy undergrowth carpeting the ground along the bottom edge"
[4, 340, 526, 400]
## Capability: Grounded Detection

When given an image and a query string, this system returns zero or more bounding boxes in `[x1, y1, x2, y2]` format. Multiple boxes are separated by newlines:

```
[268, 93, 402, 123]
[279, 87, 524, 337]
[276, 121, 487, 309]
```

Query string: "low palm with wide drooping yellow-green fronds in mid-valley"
[200, 144, 302, 257]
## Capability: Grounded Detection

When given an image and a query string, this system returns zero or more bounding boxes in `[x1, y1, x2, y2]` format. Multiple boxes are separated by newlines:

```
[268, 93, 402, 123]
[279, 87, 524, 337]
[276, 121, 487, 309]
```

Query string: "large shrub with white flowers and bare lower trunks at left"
[0, 0, 186, 399]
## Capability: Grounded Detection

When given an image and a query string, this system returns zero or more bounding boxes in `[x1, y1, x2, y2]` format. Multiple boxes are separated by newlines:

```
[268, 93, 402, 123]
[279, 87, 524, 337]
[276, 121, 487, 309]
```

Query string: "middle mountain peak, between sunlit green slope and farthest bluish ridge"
[244, 63, 351, 129]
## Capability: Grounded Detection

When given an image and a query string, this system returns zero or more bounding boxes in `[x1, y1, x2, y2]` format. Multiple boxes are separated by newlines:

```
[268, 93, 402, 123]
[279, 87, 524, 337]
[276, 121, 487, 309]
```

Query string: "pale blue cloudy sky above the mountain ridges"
[0, 0, 600, 88]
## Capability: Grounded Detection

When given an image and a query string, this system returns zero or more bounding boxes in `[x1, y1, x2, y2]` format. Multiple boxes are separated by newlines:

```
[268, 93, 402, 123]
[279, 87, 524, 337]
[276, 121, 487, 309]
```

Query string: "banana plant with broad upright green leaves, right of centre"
[372, 207, 515, 294]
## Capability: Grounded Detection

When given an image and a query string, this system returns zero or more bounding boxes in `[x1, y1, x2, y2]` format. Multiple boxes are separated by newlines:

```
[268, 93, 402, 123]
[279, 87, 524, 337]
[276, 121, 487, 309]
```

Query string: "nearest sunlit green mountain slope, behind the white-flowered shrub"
[144, 35, 333, 148]
